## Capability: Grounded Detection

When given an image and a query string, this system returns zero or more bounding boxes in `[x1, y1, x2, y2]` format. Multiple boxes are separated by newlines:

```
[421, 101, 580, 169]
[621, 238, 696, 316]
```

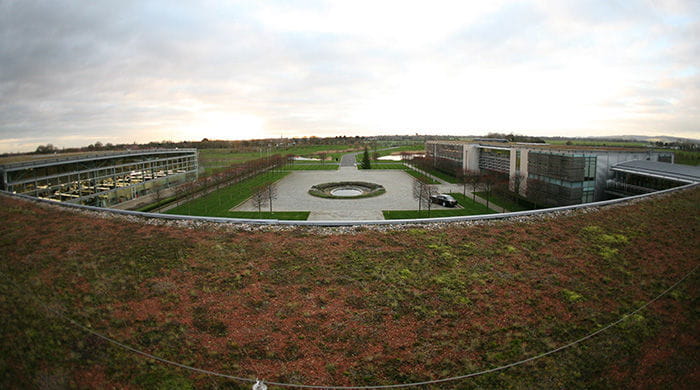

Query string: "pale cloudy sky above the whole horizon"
[0, 0, 700, 152]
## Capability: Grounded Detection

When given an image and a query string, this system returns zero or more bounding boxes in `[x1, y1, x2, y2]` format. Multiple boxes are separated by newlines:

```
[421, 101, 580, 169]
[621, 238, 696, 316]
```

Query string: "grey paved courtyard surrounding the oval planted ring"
[233, 166, 432, 221]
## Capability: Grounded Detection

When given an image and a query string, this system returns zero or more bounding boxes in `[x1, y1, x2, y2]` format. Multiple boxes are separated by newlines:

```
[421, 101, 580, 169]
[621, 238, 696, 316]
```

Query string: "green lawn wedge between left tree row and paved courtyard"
[165, 171, 289, 218]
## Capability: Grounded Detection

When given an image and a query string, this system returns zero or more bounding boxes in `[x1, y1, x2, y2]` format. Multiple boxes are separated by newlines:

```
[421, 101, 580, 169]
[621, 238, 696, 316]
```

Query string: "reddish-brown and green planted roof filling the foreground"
[0, 188, 700, 390]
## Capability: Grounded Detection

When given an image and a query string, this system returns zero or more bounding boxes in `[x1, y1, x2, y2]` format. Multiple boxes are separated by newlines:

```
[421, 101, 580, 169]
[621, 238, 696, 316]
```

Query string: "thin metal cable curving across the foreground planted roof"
[0, 266, 698, 390]
